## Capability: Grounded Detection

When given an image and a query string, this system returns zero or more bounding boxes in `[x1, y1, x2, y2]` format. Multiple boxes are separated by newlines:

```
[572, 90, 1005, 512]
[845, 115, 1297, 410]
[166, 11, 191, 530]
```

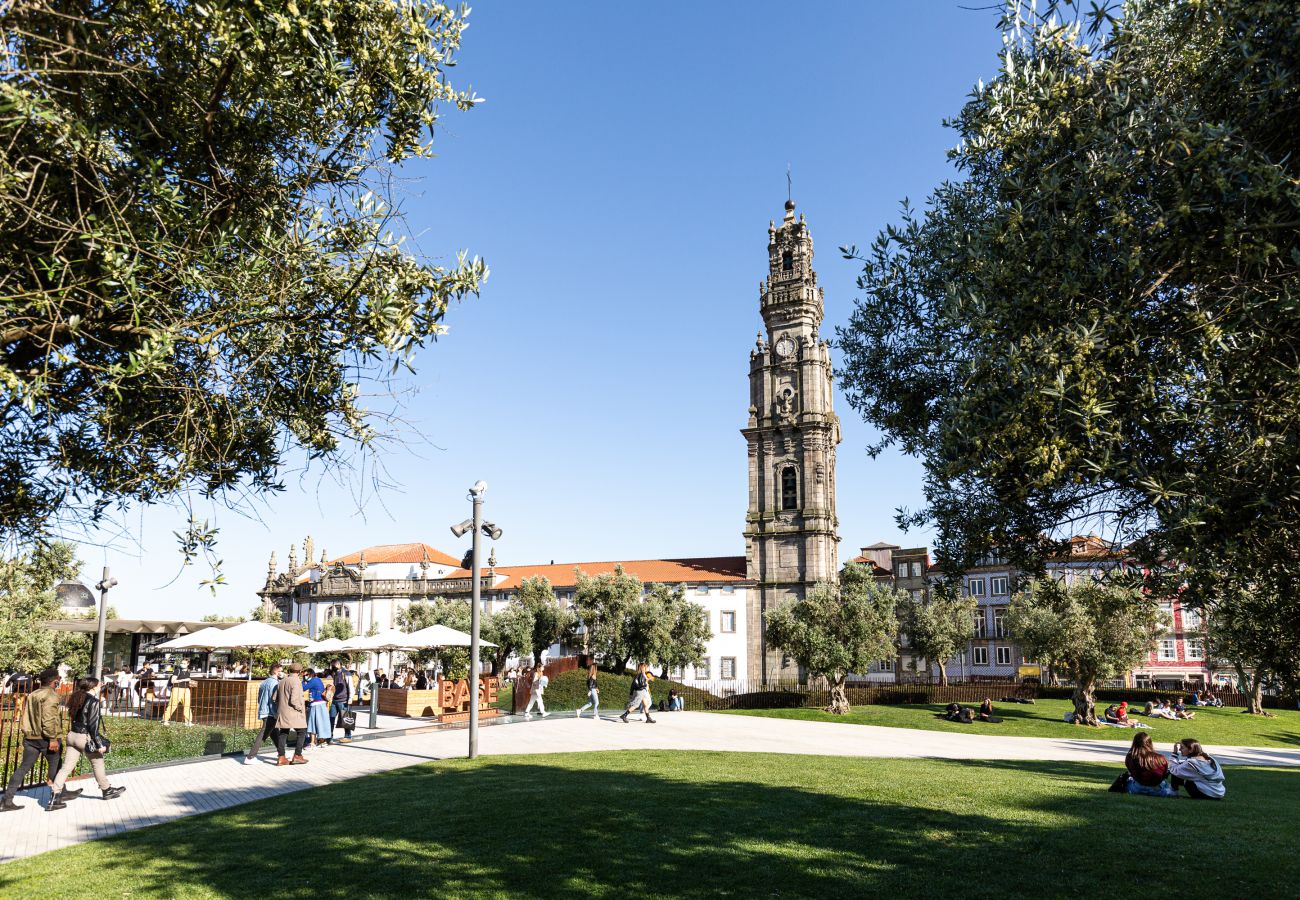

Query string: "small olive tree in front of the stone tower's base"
[767, 563, 905, 713]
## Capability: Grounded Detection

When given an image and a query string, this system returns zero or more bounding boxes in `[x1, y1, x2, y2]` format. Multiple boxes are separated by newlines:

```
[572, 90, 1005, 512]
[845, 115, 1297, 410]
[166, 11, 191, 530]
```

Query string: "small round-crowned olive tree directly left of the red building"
[1006, 579, 1170, 724]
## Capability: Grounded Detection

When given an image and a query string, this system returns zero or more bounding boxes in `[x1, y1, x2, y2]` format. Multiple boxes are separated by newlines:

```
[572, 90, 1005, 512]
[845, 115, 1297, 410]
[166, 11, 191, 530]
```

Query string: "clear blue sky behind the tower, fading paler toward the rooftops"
[81, 0, 1001, 618]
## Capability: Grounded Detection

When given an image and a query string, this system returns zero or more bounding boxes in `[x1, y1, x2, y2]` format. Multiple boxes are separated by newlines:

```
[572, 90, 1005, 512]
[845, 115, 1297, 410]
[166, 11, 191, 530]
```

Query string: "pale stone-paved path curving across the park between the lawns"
[0, 713, 1300, 862]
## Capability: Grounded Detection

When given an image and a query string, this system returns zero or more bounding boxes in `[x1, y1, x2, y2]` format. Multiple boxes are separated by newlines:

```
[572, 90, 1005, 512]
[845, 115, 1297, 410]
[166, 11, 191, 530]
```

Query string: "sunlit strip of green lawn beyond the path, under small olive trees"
[725, 700, 1300, 749]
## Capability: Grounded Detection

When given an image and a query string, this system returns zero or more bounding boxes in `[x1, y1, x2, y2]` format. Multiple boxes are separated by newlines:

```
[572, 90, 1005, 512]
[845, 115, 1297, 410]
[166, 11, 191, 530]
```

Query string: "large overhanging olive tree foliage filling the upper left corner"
[0, 0, 488, 543]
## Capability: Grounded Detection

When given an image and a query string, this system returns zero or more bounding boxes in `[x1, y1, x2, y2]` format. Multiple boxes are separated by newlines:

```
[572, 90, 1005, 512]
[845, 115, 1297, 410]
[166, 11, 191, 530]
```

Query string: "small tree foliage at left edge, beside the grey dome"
[0, 542, 81, 672]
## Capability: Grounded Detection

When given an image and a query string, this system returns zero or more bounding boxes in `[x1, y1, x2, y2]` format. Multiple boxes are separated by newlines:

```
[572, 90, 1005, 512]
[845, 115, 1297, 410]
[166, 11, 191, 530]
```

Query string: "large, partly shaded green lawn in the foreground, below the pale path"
[0, 752, 1300, 899]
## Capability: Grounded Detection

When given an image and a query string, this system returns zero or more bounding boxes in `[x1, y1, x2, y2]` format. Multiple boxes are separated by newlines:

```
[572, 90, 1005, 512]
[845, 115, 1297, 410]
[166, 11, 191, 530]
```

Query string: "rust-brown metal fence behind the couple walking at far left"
[0, 675, 259, 787]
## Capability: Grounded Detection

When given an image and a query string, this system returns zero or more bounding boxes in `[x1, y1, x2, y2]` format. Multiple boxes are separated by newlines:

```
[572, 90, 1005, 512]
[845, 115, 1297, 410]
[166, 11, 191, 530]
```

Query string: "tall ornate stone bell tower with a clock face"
[741, 200, 840, 682]
